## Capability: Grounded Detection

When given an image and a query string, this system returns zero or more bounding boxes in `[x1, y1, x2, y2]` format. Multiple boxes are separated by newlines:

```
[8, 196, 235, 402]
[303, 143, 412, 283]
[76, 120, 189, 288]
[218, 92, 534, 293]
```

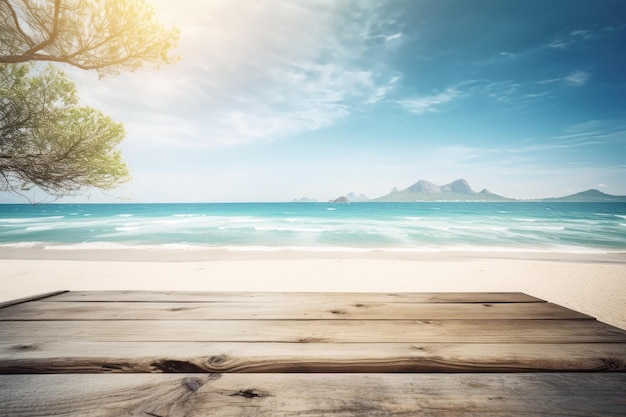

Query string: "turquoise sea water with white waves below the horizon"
[0, 202, 626, 253]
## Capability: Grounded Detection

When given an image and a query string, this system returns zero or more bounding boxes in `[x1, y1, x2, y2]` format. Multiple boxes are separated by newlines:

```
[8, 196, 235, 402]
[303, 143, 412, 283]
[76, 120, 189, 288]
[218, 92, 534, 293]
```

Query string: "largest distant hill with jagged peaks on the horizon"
[372, 179, 513, 202]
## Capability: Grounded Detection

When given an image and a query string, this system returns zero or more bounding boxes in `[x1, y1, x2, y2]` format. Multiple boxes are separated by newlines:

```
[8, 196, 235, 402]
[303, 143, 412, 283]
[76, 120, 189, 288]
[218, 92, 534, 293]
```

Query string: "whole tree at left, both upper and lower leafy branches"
[0, 0, 179, 197]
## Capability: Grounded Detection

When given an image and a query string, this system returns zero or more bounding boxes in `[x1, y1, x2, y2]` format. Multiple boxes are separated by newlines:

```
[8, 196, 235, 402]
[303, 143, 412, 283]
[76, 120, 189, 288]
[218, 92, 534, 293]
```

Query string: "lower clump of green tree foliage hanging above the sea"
[0, 65, 129, 196]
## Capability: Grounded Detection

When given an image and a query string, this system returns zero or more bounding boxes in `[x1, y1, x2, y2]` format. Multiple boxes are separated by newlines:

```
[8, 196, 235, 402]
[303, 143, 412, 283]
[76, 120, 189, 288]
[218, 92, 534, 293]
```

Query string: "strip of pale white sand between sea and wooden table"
[0, 250, 626, 329]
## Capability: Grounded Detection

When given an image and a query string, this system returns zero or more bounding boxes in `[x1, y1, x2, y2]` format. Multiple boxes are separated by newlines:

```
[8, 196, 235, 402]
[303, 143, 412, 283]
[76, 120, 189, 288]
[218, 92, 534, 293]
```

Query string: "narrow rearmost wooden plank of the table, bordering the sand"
[49, 291, 543, 304]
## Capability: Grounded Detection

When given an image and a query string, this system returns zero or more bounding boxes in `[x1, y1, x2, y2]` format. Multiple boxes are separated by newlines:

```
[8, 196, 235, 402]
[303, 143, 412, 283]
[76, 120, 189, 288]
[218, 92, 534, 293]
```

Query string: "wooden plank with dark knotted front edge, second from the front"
[0, 341, 626, 373]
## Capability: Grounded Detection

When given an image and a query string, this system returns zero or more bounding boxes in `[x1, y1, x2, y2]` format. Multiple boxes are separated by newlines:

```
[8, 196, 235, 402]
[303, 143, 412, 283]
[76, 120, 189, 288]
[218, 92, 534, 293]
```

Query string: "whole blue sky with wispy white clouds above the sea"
[0, 0, 626, 202]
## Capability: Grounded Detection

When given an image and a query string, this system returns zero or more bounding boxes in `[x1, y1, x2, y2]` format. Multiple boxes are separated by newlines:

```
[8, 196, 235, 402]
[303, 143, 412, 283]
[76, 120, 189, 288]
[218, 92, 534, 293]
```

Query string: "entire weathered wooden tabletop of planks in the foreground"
[0, 291, 626, 416]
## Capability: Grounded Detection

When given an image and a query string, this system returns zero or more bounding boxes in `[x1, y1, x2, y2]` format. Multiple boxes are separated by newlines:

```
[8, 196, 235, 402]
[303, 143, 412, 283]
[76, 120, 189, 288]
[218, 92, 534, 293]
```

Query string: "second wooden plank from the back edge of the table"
[0, 299, 593, 321]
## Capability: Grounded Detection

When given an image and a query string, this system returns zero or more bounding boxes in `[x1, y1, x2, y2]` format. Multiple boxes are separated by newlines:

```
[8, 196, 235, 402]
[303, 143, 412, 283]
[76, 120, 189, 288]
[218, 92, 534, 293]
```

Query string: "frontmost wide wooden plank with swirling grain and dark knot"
[0, 373, 626, 417]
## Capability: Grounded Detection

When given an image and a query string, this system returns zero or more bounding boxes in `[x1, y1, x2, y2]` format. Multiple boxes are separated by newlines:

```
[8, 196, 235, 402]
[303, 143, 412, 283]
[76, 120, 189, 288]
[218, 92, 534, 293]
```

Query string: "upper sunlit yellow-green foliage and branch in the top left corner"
[0, 0, 178, 75]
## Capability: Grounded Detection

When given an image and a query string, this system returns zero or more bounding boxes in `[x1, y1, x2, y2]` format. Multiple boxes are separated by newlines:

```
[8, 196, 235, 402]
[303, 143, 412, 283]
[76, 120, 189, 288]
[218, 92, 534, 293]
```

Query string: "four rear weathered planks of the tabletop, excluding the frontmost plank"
[0, 292, 626, 373]
